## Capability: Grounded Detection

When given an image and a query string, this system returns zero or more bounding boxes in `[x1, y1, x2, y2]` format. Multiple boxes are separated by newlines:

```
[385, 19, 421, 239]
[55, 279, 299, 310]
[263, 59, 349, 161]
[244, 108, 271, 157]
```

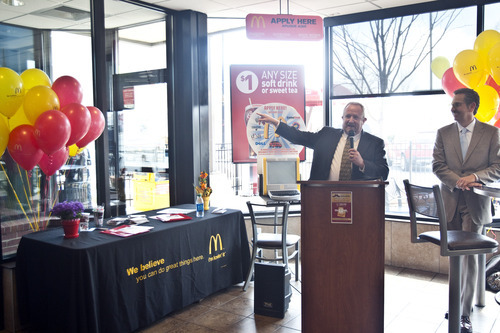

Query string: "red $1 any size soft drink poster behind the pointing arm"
[230, 65, 305, 163]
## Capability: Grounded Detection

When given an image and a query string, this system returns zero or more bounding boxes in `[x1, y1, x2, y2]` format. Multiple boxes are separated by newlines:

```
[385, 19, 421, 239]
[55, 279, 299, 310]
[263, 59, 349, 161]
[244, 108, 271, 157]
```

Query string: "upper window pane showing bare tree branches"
[330, 8, 476, 96]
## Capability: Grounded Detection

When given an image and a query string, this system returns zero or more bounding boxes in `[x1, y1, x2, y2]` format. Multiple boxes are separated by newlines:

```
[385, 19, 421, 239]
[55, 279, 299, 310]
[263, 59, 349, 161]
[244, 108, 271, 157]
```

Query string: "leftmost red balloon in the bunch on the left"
[7, 124, 43, 170]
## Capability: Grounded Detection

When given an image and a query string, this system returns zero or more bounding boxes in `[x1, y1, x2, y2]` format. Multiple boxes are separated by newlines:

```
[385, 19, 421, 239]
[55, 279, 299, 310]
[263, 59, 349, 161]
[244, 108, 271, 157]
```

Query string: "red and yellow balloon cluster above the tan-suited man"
[431, 30, 500, 127]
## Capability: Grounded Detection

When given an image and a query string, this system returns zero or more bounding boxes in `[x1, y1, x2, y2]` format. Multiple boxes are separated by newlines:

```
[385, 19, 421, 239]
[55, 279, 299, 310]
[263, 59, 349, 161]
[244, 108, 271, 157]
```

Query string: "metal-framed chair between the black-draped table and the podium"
[243, 201, 300, 291]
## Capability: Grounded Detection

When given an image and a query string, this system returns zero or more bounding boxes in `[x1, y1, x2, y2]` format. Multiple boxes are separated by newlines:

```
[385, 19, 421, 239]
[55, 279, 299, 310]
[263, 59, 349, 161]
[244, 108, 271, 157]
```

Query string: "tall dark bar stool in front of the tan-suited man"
[403, 179, 498, 333]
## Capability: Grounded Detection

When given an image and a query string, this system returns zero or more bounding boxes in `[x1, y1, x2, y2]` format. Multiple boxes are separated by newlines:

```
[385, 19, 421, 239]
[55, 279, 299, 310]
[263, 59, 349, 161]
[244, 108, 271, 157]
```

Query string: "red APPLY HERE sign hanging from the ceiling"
[246, 14, 323, 41]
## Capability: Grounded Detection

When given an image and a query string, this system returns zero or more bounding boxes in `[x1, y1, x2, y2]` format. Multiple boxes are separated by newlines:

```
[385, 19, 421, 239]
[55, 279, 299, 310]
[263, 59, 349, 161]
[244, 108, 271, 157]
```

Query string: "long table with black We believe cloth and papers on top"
[16, 205, 250, 333]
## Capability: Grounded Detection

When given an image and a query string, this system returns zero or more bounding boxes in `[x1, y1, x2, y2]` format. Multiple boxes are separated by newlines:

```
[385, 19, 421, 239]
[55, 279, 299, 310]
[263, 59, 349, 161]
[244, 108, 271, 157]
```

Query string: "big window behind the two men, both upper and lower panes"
[324, 7, 484, 215]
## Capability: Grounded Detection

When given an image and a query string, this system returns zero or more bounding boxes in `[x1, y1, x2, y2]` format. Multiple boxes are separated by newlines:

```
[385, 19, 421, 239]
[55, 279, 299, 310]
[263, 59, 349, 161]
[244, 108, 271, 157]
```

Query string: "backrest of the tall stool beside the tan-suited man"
[403, 179, 449, 255]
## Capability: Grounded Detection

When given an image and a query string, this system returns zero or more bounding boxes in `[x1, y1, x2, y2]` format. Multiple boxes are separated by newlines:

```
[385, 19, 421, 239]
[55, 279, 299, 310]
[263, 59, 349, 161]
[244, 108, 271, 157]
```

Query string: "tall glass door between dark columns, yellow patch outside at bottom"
[108, 17, 170, 214]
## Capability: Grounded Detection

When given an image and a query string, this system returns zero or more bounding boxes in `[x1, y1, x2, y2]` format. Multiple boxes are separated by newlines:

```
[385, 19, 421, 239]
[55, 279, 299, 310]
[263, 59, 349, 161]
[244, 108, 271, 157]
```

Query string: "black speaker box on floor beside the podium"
[254, 262, 292, 318]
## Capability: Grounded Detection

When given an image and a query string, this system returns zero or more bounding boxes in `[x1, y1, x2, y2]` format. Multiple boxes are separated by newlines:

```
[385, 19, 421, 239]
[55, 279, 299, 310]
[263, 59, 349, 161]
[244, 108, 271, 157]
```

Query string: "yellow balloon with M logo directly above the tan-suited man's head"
[453, 50, 488, 89]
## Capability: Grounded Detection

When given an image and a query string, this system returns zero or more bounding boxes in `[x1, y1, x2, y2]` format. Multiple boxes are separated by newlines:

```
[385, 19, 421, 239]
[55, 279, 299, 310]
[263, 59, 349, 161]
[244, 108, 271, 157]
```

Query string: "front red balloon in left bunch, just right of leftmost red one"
[34, 110, 71, 155]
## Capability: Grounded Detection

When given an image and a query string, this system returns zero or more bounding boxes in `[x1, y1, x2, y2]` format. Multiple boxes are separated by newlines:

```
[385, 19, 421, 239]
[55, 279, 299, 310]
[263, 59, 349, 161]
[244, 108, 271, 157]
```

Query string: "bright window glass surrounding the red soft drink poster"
[209, 27, 324, 205]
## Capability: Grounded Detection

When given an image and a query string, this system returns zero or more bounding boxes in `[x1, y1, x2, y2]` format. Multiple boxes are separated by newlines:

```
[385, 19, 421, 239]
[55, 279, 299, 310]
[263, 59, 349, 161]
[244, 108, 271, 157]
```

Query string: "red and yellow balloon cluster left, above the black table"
[0, 67, 105, 177]
